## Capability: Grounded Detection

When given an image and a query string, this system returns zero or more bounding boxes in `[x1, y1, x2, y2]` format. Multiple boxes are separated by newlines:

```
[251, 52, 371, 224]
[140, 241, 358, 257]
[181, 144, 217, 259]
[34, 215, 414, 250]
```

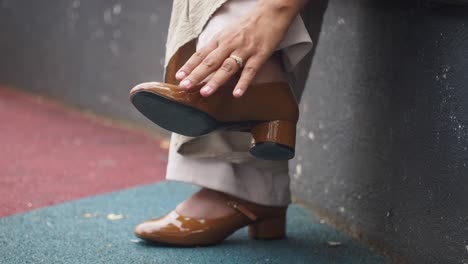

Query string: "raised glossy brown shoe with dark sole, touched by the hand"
[130, 82, 299, 160]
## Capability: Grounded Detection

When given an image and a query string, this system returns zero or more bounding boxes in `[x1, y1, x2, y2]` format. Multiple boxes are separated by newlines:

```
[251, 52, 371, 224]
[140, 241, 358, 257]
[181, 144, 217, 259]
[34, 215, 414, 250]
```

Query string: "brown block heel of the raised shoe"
[250, 120, 296, 160]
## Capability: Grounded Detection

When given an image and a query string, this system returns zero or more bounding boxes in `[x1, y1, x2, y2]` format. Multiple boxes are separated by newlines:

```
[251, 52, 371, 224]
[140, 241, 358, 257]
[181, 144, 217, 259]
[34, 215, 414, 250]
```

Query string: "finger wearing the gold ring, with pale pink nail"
[200, 53, 240, 96]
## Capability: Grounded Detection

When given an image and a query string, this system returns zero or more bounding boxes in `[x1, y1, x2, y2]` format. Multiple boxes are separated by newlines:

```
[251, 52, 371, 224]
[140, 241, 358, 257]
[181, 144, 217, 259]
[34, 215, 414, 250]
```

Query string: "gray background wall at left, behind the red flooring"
[0, 0, 172, 133]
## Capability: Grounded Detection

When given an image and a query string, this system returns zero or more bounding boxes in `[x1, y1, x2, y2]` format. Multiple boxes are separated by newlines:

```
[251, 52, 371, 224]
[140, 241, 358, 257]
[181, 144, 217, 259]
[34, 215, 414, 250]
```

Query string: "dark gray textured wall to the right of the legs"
[291, 0, 468, 263]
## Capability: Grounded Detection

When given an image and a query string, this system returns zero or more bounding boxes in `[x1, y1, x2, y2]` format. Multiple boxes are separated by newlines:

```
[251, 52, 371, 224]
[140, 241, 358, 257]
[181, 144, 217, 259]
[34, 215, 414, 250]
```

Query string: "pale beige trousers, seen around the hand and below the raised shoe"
[166, 0, 312, 206]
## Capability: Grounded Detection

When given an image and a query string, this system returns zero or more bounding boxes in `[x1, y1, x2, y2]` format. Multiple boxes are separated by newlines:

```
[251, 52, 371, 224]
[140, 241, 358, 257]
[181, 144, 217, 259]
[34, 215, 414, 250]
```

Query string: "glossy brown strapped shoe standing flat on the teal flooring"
[135, 193, 287, 246]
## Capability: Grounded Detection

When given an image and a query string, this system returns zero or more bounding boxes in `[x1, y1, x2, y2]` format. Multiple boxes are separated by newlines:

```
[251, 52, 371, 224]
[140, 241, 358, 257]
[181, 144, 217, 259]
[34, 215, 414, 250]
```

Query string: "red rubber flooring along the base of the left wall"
[0, 86, 167, 217]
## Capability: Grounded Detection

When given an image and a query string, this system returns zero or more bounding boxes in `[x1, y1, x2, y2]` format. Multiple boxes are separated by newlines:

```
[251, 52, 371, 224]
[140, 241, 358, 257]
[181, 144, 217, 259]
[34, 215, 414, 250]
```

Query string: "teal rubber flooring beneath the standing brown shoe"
[0, 182, 389, 264]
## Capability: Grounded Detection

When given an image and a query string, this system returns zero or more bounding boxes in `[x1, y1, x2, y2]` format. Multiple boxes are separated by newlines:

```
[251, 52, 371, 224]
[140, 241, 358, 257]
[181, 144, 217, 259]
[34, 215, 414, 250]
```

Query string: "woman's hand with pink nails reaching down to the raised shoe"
[176, 0, 306, 97]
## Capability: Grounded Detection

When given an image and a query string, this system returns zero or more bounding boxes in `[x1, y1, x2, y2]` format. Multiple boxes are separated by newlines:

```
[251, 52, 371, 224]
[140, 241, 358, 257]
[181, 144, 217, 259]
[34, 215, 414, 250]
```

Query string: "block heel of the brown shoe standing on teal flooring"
[249, 216, 286, 239]
